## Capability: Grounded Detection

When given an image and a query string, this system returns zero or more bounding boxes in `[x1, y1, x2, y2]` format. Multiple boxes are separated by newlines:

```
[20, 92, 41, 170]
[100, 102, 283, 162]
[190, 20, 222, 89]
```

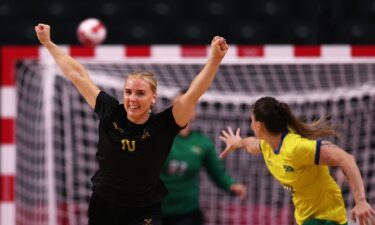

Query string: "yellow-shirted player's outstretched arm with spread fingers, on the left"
[220, 127, 261, 158]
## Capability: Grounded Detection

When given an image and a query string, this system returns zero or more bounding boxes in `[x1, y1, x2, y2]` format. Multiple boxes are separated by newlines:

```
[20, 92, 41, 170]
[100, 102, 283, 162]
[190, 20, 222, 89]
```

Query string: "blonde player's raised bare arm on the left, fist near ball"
[35, 24, 100, 108]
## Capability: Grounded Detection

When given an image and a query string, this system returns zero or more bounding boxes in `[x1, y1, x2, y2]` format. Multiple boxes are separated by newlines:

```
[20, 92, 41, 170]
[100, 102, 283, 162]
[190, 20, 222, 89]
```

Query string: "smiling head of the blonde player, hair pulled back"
[124, 77, 156, 124]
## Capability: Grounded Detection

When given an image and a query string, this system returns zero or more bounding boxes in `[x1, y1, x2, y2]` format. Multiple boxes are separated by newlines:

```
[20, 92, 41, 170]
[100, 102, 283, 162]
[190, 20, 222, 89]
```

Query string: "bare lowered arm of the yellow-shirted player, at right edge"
[319, 141, 375, 225]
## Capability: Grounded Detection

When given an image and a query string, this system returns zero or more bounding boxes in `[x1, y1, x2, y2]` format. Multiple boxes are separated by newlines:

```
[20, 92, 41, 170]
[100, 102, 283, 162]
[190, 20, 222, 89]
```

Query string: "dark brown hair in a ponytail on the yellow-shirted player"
[253, 97, 337, 139]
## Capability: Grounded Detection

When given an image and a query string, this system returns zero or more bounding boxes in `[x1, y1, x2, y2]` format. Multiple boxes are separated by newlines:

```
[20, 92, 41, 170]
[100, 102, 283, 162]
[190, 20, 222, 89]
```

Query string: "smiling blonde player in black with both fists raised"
[35, 24, 228, 225]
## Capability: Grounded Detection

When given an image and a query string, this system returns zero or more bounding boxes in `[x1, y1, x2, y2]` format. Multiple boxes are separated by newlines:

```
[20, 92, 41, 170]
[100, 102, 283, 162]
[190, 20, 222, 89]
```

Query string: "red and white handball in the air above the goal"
[77, 18, 107, 46]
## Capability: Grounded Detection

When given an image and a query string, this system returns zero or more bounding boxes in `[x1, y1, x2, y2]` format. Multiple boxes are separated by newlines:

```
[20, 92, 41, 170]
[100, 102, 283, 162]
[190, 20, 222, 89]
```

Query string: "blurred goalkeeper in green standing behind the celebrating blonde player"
[160, 90, 247, 225]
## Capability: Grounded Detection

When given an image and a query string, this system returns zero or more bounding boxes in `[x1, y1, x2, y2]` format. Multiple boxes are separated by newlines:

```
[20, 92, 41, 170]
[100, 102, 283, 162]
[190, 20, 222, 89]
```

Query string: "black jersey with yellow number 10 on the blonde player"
[92, 91, 181, 207]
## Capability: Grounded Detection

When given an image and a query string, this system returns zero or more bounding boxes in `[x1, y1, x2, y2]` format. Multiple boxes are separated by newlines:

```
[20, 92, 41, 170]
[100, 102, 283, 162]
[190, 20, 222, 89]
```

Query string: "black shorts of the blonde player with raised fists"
[88, 194, 161, 225]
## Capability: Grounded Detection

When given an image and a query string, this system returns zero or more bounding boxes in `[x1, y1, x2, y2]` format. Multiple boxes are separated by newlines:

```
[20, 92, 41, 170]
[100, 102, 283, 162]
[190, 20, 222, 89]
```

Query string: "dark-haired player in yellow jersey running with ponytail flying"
[220, 97, 375, 225]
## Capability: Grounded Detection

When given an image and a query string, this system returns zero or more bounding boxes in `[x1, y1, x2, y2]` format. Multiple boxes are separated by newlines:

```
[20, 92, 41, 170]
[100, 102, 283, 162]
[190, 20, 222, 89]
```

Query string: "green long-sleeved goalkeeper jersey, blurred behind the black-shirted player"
[160, 131, 235, 216]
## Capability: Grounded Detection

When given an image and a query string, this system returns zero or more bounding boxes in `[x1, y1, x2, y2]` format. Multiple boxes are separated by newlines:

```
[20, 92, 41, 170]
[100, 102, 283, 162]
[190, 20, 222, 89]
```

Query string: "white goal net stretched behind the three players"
[16, 55, 375, 225]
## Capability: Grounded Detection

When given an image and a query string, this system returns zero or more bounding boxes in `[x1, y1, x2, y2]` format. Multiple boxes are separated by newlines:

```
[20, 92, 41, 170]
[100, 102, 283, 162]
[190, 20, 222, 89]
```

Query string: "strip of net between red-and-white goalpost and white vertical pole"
[15, 62, 48, 225]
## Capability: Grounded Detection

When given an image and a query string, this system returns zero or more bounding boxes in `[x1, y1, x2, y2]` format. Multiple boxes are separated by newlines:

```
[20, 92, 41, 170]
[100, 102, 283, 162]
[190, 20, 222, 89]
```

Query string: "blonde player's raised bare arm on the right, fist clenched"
[173, 36, 228, 126]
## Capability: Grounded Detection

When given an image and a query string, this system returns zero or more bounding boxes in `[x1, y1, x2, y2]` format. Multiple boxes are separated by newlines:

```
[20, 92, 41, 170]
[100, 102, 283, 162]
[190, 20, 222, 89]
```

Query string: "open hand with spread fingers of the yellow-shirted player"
[219, 127, 244, 159]
